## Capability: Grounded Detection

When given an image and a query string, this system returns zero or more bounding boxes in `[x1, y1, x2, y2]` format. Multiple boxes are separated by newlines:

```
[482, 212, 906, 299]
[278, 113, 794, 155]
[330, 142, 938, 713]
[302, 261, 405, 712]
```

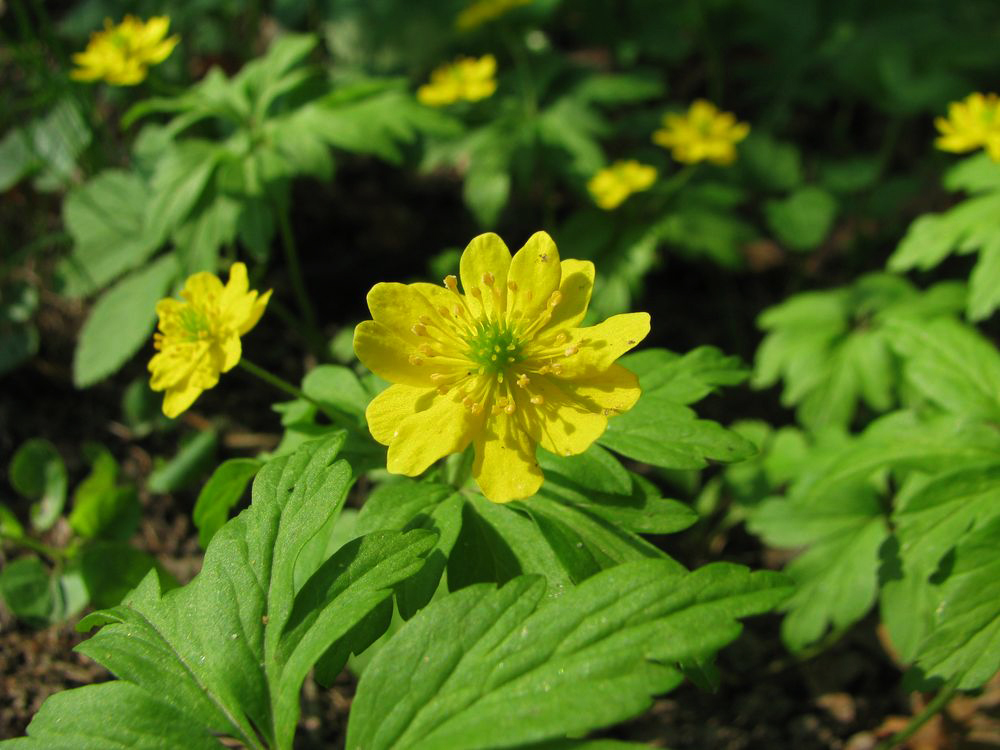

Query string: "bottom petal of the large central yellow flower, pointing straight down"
[472, 412, 544, 503]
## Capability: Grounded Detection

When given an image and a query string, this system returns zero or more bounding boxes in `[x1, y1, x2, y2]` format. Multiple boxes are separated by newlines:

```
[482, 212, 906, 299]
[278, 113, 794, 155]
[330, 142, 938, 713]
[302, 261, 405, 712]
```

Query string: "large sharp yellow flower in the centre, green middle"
[354, 232, 649, 502]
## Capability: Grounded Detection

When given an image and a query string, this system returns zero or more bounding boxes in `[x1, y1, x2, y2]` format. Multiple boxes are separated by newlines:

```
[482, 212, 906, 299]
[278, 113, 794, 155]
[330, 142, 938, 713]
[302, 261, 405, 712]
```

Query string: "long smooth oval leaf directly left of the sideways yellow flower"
[73, 255, 178, 388]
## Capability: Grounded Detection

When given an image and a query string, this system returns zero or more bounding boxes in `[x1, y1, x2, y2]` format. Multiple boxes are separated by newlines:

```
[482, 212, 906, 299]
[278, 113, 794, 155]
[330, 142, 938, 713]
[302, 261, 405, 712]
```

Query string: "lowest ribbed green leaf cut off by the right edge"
[917, 518, 1000, 690]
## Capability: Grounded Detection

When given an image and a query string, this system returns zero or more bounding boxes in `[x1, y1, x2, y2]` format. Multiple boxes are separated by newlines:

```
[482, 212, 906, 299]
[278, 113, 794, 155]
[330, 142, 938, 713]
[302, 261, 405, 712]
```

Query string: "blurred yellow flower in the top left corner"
[70, 16, 180, 86]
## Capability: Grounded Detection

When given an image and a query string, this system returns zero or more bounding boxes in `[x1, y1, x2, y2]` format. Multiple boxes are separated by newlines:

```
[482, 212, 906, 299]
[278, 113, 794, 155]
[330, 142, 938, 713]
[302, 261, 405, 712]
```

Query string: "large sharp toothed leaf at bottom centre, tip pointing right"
[346, 560, 788, 750]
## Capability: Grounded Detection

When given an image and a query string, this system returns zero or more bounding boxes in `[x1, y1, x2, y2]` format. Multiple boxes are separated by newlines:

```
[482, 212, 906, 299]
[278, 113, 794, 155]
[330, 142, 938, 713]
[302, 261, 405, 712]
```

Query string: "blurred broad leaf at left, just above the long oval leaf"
[61, 169, 160, 296]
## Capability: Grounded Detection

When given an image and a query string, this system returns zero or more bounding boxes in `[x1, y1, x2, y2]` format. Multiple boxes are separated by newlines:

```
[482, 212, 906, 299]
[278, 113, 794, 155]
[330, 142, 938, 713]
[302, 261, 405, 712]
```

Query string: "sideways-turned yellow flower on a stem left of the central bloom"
[149, 263, 271, 417]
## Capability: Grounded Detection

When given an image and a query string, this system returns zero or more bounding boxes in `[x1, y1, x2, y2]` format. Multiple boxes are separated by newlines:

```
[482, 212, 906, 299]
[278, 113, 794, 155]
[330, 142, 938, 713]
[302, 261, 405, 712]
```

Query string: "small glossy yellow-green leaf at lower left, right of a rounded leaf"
[69, 445, 139, 540]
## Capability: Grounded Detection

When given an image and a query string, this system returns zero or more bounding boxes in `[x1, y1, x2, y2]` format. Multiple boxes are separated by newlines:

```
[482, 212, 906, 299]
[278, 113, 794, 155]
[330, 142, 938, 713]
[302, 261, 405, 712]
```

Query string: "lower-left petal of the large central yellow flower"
[386, 394, 482, 477]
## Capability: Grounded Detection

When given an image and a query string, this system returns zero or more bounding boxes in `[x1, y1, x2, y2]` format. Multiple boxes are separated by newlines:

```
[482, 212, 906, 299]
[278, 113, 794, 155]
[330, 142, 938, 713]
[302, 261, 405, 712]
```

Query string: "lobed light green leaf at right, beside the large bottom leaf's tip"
[750, 485, 889, 651]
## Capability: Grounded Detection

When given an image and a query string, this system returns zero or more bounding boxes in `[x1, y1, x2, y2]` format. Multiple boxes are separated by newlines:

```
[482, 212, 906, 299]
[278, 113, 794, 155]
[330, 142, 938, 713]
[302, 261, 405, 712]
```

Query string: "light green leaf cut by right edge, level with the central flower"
[888, 318, 1000, 421]
